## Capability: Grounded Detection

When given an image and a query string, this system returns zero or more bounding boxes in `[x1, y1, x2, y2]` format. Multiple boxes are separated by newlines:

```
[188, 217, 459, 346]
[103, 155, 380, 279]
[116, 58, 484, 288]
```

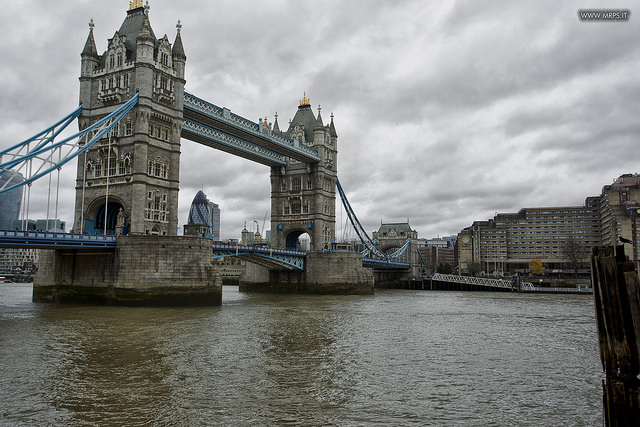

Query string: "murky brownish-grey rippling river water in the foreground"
[0, 284, 604, 426]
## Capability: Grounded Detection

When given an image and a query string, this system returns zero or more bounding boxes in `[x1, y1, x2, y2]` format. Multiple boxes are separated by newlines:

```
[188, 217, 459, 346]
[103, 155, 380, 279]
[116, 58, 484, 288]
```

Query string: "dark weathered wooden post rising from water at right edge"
[591, 245, 640, 427]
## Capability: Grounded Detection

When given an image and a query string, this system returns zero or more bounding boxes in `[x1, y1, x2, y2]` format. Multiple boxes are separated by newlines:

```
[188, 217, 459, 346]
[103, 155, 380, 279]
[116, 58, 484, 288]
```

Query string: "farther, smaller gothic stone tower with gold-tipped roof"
[271, 94, 338, 251]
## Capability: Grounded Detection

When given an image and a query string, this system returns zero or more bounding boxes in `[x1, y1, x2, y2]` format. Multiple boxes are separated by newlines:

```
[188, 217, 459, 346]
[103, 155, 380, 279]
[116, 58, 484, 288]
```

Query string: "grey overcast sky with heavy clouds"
[0, 0, 640, 239]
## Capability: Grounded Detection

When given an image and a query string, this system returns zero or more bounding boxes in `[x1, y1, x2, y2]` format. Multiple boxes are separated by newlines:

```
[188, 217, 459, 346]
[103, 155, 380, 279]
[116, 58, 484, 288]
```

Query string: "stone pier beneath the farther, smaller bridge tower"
[240, 252, 374, 295]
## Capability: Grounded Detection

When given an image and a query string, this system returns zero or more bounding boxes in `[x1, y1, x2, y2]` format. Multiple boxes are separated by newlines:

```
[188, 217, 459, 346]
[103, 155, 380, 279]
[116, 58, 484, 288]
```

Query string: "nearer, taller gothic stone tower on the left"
[73, 0, 186, 235]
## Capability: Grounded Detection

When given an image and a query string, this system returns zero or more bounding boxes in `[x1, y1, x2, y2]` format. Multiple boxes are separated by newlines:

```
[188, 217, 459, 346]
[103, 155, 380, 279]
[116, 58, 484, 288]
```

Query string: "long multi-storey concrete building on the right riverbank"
[456, 174, 640, 274]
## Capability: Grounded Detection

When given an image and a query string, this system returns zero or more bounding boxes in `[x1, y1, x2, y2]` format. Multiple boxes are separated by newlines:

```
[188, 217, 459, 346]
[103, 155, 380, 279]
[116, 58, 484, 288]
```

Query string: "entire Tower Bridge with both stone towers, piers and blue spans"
[0, 1, 417, 304]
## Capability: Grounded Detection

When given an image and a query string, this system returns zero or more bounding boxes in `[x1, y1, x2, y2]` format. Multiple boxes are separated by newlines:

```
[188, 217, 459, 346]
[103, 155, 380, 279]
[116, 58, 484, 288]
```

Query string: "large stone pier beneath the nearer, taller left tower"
[33, 236, 222, 306]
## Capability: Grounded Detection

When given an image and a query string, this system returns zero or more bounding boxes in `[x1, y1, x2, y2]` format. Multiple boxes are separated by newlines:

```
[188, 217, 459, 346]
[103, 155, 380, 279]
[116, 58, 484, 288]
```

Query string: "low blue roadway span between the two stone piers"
[213, 244, 307, 270]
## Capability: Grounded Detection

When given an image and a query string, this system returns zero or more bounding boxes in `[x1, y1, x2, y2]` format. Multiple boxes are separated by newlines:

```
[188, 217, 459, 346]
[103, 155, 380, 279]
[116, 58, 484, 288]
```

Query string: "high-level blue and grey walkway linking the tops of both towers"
[182, 93, 320, 166]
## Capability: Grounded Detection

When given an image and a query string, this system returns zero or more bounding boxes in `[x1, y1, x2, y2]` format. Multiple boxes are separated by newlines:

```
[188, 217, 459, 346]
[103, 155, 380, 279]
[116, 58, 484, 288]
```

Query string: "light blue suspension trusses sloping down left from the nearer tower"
[0, 93, 138, 194]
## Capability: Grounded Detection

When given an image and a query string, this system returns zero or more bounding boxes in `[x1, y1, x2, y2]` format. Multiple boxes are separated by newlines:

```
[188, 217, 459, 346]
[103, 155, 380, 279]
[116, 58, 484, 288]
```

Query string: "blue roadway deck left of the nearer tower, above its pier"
[0, 230, 116, 249]
